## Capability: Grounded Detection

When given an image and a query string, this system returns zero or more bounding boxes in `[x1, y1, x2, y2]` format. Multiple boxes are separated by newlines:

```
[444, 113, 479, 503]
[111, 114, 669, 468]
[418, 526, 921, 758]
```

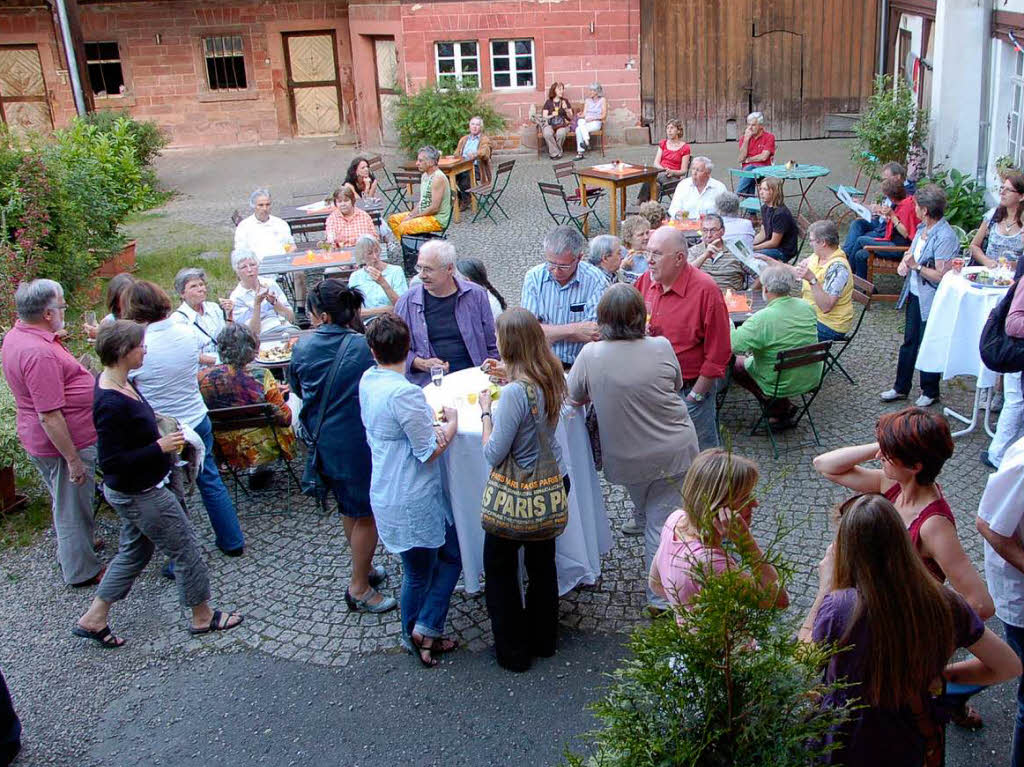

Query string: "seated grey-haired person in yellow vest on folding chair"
[792, 220, 853, 341]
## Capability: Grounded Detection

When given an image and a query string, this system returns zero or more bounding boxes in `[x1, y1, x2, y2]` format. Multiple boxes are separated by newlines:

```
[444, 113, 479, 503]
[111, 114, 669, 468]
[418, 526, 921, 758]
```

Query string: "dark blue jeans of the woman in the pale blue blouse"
[398, 524, 462, 643]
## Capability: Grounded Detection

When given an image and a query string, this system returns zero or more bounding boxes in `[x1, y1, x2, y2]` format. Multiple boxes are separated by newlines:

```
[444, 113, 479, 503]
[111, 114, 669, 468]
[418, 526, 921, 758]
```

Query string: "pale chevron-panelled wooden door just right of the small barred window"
[285, 30, 347, 136]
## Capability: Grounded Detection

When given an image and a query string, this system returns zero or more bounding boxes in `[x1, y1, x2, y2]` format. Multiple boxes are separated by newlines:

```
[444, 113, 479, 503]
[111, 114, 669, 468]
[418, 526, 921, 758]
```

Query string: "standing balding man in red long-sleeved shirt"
[636, 226, 732, 451]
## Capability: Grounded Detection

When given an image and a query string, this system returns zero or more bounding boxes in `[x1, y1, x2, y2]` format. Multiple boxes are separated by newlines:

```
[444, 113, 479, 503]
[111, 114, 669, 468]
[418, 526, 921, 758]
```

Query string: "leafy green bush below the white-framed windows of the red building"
[395, 85, 506, 155]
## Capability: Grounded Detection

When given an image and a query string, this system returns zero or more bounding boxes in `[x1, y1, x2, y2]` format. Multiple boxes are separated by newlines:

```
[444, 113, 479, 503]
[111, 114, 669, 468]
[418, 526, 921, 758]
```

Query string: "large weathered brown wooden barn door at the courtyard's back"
[640, 0, 877, 142]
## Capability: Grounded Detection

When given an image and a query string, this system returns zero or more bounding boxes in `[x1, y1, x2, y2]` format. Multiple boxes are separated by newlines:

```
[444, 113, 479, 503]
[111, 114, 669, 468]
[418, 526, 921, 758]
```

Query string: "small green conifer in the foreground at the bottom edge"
[568, 507, 849, 767]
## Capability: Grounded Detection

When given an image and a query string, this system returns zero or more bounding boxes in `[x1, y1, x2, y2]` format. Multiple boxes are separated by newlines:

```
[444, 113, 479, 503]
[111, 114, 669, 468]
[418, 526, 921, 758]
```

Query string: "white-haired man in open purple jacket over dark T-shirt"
[394, 240, 498, 386]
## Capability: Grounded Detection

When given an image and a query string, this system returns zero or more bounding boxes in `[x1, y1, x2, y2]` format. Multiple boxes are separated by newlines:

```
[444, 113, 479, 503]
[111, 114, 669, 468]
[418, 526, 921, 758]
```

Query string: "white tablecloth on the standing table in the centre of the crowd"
[424, 368, 611, 594]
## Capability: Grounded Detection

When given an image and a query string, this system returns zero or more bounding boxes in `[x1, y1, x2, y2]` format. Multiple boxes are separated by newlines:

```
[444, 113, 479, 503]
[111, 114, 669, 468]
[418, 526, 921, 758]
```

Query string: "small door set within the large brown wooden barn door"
[751, 31, 804, 140]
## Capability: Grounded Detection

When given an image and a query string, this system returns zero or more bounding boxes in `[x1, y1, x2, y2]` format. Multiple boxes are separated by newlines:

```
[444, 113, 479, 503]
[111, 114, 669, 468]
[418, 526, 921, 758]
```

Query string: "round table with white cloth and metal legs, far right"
[915, 272, 1007, 437]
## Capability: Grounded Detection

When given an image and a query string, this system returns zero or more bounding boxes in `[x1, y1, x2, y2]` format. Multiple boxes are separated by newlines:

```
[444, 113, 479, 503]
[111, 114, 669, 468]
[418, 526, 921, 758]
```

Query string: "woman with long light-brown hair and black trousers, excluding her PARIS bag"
[479, 307, 569, 671]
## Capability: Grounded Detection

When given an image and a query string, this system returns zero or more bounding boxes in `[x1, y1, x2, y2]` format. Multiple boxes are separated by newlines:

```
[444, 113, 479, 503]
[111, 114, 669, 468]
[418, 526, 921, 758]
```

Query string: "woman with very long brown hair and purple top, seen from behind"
[800, 494, 1021, 767]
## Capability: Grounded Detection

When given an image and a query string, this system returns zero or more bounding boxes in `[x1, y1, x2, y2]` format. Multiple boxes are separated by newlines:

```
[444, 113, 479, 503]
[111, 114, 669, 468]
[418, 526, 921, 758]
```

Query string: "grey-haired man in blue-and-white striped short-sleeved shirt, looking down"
[520, 226, 608, 368]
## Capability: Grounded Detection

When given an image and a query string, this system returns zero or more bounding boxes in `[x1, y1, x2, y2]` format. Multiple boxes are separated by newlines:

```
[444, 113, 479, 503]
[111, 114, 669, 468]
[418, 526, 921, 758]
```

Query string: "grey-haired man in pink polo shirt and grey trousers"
[0, 280, 103, 586]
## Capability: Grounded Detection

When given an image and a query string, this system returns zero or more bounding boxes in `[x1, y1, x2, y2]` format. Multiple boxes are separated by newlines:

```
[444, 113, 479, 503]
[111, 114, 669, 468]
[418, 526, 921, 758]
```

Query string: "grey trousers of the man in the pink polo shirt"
[30, 444, 102, 584]
